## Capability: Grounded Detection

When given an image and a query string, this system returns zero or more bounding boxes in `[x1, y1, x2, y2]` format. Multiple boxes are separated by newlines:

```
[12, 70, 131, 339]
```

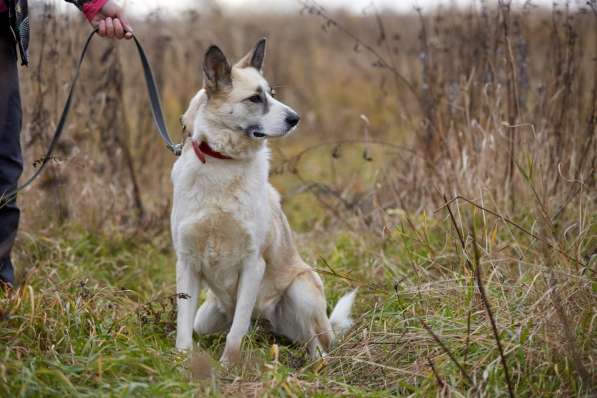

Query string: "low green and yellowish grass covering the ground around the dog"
[0, 199, 596, 397]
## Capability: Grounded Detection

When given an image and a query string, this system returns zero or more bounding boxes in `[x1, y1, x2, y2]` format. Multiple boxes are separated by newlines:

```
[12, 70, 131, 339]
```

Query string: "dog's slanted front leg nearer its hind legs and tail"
[220, 256, 265, 365]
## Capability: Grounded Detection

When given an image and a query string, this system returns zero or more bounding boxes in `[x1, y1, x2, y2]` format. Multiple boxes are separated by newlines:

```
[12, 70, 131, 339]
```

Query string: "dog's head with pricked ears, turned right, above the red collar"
[182, 39, 300, 157]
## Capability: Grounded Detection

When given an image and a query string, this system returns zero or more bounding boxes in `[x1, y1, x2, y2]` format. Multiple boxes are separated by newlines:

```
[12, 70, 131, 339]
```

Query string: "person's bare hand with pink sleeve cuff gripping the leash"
[66, 0, 133, 39]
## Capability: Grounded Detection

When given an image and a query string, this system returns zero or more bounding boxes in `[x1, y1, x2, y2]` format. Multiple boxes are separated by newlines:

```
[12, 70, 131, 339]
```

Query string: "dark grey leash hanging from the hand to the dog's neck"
[0, 29, 182, 208]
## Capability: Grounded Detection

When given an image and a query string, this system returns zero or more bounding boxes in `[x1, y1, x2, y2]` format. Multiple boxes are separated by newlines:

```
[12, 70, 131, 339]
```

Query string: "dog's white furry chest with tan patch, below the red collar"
[172, 152, 269, 274]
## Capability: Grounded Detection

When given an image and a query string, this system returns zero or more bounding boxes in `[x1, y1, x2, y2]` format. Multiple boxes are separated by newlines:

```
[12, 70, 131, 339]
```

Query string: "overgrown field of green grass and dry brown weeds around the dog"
[0, 0, 597, 397]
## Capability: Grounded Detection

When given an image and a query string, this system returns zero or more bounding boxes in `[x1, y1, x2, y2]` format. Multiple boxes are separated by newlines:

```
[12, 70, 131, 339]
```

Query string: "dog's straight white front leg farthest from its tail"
[176, 259, 200, 351]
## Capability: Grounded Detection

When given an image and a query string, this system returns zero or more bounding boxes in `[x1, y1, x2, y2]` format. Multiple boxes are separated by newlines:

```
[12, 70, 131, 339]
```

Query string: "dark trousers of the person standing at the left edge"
[0, 13, 23, 284]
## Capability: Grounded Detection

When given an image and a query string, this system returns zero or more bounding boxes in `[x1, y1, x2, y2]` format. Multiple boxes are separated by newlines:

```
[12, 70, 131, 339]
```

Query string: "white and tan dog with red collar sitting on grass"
[171, 39, 356, 365]
